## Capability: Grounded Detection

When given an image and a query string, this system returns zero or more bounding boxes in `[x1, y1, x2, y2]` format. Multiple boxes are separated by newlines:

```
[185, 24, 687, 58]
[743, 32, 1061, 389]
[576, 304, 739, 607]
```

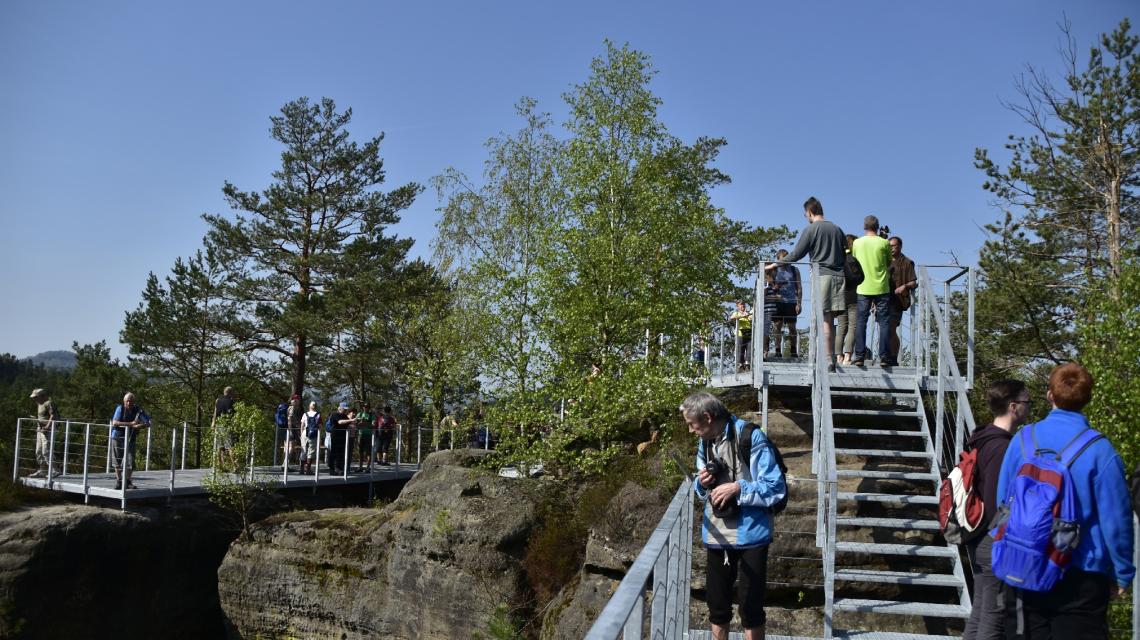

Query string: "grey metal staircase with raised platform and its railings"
[587, 266, 1140, 640]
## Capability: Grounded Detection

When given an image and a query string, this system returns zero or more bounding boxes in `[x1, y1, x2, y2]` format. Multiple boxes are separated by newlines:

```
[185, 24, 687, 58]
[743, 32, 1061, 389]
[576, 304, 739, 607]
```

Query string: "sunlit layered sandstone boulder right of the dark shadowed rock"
[218, 451, 544, 639]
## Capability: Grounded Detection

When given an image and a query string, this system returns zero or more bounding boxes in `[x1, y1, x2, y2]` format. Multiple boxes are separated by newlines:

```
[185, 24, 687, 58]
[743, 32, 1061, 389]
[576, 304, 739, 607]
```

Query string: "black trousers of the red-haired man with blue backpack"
[1004, 567, 1116, 640]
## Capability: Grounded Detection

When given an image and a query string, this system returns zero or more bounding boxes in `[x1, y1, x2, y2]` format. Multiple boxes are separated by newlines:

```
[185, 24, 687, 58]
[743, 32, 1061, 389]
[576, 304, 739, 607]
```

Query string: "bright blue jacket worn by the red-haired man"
[998, 408, 1137, 588]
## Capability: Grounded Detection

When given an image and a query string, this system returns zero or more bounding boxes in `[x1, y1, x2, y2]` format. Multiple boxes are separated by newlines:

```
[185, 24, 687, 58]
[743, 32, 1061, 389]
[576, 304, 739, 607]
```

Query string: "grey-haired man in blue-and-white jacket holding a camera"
[681, 391, 788, 640]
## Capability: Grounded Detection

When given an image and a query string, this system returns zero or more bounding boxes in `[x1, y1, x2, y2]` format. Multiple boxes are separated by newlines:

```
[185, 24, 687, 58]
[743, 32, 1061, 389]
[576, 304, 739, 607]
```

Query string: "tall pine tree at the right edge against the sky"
[975, 19, 1140, 384]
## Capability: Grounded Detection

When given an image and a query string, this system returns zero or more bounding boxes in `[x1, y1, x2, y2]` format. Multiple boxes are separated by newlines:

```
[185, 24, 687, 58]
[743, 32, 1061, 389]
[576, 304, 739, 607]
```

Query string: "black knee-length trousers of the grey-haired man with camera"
[706, 545, 768, 629]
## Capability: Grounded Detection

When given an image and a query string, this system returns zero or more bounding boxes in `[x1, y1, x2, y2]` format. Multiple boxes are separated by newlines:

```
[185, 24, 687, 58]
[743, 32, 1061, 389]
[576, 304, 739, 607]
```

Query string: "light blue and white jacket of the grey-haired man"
[693, 415, 788, 549]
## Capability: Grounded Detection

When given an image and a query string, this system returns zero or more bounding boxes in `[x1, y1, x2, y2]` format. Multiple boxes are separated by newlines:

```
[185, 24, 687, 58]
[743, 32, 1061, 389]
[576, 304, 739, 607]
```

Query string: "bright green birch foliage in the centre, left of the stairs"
[434, 42, 787, 473]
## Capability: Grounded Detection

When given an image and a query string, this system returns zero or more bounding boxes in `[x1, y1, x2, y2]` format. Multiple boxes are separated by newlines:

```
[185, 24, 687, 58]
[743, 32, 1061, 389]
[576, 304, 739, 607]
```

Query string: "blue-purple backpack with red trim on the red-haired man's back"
[990, 426, 1104, 591]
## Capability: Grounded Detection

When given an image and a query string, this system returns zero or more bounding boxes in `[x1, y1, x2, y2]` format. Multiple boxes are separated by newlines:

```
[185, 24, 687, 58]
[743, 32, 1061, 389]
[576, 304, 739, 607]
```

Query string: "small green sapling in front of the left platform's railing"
[203, 402, 274, 540]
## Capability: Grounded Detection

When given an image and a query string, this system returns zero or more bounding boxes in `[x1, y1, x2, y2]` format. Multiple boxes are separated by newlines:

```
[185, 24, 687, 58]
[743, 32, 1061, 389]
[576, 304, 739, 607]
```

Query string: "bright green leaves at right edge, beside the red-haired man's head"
[1077, 258, 1140, 470]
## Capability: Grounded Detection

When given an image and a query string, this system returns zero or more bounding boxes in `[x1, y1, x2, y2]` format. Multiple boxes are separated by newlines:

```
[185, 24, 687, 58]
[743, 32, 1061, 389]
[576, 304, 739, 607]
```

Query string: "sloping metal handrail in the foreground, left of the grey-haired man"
[586, 478, 693, 640]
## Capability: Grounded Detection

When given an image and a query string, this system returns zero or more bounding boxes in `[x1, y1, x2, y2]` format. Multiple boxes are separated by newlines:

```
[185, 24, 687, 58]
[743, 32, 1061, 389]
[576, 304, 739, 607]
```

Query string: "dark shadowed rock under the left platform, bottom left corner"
[0, 502, 236, 640]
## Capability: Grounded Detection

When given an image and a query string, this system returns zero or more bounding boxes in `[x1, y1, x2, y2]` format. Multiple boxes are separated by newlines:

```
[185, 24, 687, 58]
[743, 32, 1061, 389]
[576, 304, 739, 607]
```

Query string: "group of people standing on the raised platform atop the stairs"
[720, 197, 918, 372]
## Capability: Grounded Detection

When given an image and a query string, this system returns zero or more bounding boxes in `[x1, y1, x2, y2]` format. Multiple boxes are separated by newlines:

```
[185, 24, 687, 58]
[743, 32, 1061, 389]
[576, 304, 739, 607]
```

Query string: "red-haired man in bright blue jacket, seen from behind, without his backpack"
[998, 363, 1135, 640]
